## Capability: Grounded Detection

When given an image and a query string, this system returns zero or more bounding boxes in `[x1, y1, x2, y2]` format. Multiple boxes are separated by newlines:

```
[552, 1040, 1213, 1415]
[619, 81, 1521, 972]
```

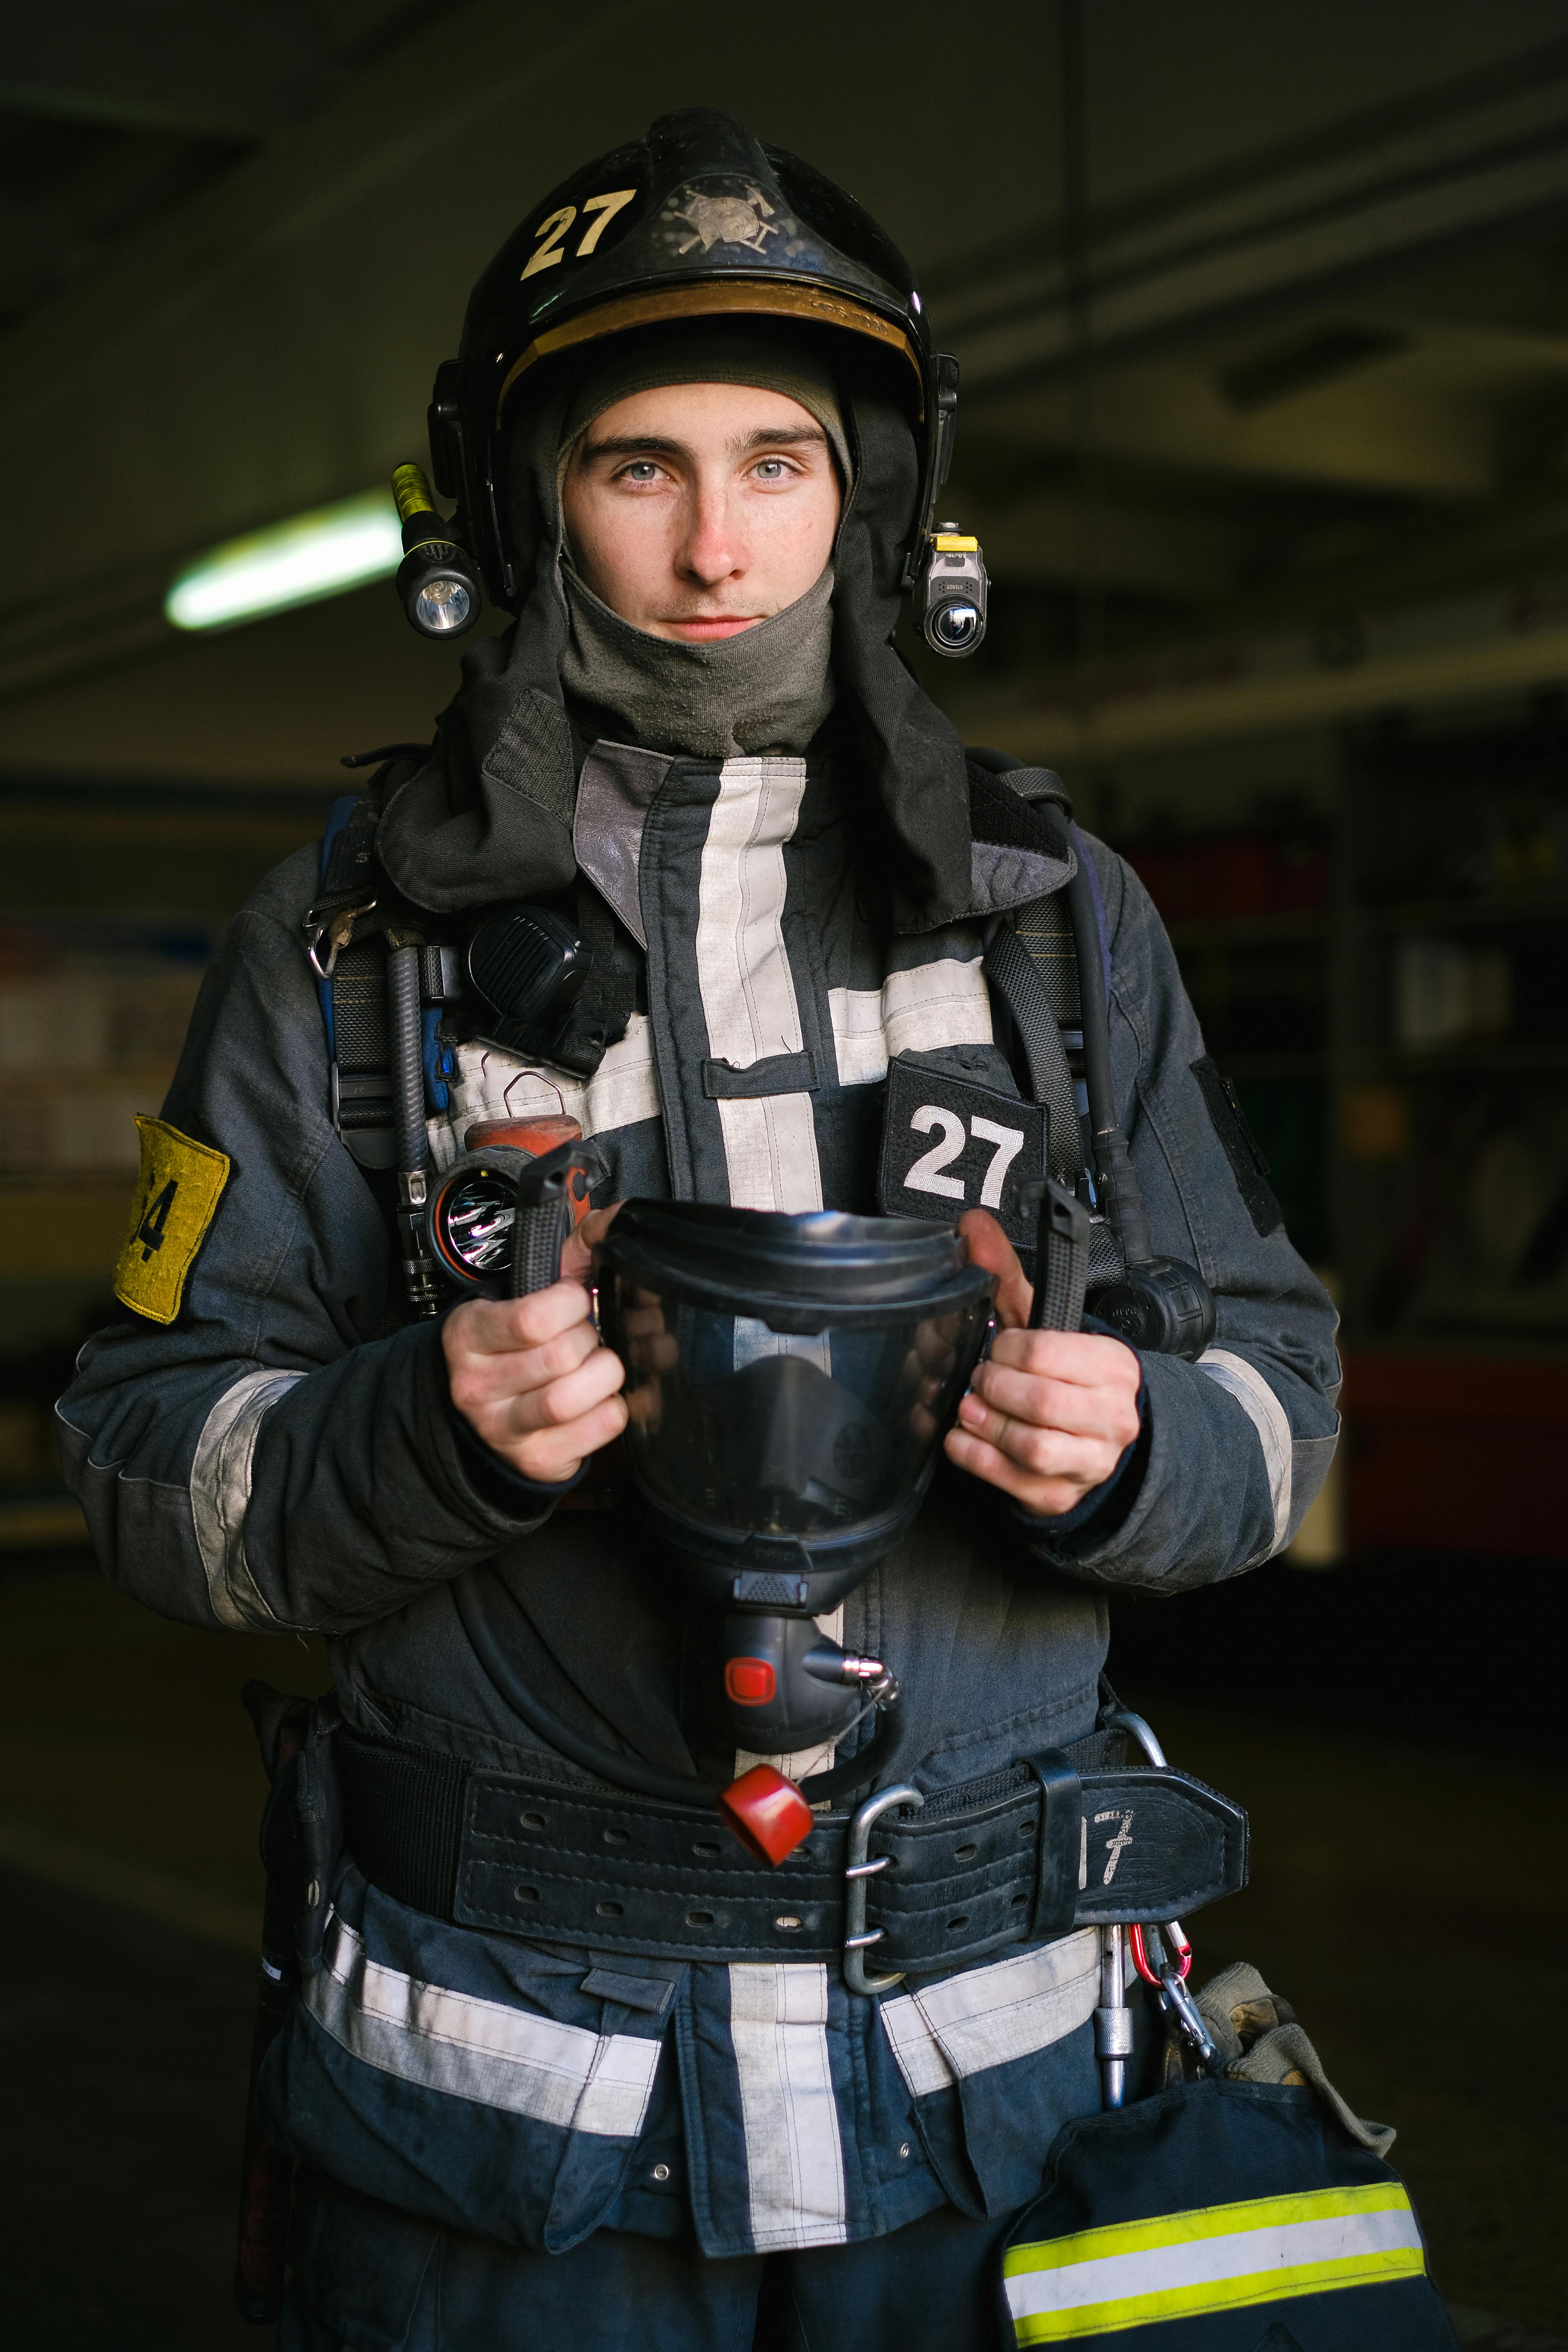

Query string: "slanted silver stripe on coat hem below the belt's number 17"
[882, 1926, 1100, 2098]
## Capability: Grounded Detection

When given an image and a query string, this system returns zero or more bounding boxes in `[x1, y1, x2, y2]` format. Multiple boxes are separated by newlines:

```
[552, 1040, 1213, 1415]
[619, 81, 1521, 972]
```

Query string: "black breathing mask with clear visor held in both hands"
[599, 1202, 994, 1752]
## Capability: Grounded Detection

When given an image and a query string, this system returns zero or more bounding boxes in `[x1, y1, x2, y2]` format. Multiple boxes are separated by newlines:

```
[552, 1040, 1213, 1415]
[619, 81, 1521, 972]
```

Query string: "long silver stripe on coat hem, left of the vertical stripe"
[303, 1919, 661, 2140]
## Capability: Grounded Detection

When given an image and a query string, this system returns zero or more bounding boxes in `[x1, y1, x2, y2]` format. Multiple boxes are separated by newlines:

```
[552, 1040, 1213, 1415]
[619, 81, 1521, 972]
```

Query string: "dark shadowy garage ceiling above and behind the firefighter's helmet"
[0, 0, 1568, 781]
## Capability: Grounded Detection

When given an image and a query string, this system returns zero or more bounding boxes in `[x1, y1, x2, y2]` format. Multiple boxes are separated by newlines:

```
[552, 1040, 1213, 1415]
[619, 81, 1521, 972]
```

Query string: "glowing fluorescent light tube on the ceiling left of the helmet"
[162, 489, 402, 628]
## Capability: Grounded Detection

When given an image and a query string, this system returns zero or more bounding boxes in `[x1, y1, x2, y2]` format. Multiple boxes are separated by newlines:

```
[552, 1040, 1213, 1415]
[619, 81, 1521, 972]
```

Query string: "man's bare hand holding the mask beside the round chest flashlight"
[442, 1218, 625, 1487]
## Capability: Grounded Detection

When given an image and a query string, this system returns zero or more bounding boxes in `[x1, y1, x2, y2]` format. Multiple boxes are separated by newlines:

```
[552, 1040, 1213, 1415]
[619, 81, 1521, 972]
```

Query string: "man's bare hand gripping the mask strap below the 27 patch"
[945, 1209, 1142, 1519]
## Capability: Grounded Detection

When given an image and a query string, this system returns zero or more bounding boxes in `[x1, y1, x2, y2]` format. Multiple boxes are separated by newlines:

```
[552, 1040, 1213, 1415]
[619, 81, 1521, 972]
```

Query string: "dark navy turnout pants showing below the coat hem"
[277, 2176, 1015, 2352]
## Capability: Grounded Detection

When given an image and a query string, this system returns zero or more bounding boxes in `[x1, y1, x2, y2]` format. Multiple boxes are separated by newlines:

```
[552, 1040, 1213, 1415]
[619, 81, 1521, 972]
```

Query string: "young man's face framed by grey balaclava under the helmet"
[562, 383, 839, 645]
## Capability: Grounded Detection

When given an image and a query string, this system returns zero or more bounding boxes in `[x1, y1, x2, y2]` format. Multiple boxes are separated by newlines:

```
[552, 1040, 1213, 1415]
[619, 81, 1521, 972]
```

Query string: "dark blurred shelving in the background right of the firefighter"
[1124, 701, 1568, 1557]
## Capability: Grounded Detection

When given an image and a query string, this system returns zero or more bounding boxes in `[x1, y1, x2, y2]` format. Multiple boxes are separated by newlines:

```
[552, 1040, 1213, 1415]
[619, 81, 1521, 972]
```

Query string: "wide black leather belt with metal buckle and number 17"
[334, 1729, 1246, 1976]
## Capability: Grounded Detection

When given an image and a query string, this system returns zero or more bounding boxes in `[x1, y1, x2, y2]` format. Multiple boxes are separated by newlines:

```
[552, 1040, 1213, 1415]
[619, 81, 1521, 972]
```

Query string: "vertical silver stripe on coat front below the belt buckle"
[729, 1962, 849, 2253]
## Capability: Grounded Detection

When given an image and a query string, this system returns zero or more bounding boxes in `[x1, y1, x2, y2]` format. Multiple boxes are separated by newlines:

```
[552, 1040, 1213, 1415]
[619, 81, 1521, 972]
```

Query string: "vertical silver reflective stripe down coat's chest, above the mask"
[696, 760, 823, 1214]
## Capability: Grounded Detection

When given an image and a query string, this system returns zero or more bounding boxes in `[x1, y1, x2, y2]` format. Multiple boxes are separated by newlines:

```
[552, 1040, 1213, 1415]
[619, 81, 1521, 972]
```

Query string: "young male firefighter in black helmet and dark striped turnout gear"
[59, 110, 1338, 2352]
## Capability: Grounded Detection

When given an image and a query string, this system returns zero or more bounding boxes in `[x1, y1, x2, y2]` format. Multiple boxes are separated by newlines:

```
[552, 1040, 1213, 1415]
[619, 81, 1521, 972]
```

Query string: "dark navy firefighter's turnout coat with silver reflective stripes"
[59, 381, 1338, 2256]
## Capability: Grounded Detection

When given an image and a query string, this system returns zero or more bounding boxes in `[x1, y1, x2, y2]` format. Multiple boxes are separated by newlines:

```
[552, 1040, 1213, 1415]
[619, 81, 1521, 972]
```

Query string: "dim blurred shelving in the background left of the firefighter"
[0, 774, 329, 1555]
